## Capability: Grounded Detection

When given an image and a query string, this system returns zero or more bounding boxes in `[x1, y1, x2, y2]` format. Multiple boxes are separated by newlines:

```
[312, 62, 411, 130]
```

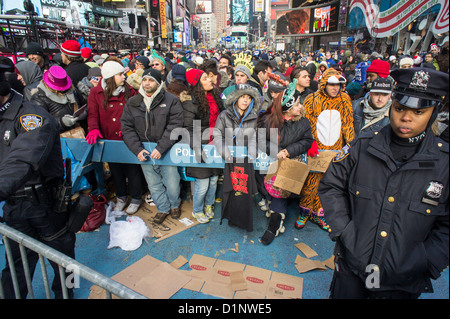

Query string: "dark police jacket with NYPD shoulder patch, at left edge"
[0, 91, 64, 201]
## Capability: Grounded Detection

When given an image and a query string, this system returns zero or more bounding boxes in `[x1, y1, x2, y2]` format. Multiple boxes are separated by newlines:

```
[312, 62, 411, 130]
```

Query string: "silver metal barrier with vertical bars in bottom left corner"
[0, 223, 147, 299]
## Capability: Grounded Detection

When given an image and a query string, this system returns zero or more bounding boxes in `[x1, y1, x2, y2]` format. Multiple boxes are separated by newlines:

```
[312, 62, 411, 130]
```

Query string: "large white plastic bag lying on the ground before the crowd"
[108, 216, 152, 251]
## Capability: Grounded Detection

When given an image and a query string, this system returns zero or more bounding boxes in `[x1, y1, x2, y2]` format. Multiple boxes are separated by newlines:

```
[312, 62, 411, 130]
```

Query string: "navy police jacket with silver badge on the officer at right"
[318, 125, 449, 293]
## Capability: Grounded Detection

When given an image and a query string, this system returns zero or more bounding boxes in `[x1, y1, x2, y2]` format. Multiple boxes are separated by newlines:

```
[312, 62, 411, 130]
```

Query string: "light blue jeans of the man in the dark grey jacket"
[141, 165, 181, 214]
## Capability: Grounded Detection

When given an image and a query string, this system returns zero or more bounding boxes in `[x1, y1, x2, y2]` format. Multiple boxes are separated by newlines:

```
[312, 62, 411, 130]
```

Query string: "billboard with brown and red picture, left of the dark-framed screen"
[275, 8, 311, 35]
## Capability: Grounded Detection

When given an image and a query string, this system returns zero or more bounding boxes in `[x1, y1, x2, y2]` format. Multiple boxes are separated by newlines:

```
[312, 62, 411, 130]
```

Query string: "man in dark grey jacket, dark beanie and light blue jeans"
[121, 68, 184, 224]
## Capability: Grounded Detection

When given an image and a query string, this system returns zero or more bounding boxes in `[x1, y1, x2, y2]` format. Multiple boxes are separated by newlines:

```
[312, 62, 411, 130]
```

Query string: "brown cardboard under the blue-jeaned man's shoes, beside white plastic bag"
[135, 201, 199, 243]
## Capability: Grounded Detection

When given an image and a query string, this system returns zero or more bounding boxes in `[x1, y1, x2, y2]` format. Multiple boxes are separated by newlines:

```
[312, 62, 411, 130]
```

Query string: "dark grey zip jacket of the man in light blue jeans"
[120, 85, 183, 156]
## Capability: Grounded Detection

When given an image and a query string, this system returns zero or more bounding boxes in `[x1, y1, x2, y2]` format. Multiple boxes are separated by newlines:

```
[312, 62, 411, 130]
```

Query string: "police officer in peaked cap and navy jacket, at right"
[318, 68, 449, 299]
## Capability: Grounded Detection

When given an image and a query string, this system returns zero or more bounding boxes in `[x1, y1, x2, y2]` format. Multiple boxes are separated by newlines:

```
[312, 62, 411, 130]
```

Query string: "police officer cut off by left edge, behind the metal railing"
[0, 65, 75, 298]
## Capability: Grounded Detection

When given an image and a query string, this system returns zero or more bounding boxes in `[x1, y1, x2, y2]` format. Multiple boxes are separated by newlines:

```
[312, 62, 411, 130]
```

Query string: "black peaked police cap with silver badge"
[391, 68, 449, 109]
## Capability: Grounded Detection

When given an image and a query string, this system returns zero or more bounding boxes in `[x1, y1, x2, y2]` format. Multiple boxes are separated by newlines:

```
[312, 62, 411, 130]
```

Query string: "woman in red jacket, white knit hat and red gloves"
[86, 61, 142, 214]
